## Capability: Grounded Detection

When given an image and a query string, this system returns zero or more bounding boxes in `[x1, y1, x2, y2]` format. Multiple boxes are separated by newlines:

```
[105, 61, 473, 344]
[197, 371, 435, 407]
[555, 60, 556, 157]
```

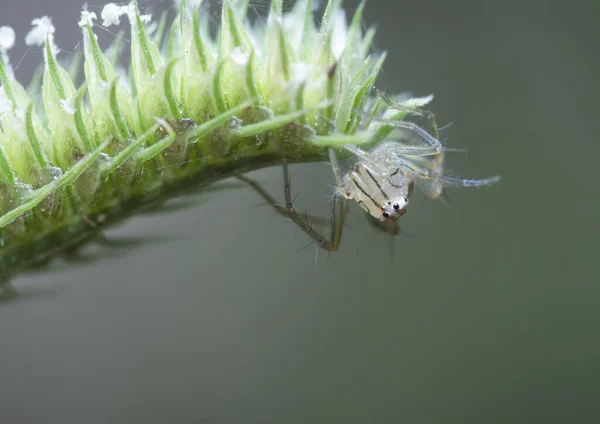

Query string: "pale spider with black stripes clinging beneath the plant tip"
[236, 92, 500, 252]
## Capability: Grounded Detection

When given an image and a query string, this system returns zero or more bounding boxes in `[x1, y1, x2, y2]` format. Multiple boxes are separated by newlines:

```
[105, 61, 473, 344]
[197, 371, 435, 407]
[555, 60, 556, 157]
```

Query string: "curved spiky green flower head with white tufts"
[0, 0, 404, 279]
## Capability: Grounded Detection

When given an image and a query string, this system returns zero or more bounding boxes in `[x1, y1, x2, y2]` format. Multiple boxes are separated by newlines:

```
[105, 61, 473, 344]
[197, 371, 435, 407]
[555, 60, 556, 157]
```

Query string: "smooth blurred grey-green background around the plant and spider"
[0, 0, 600, 423]
